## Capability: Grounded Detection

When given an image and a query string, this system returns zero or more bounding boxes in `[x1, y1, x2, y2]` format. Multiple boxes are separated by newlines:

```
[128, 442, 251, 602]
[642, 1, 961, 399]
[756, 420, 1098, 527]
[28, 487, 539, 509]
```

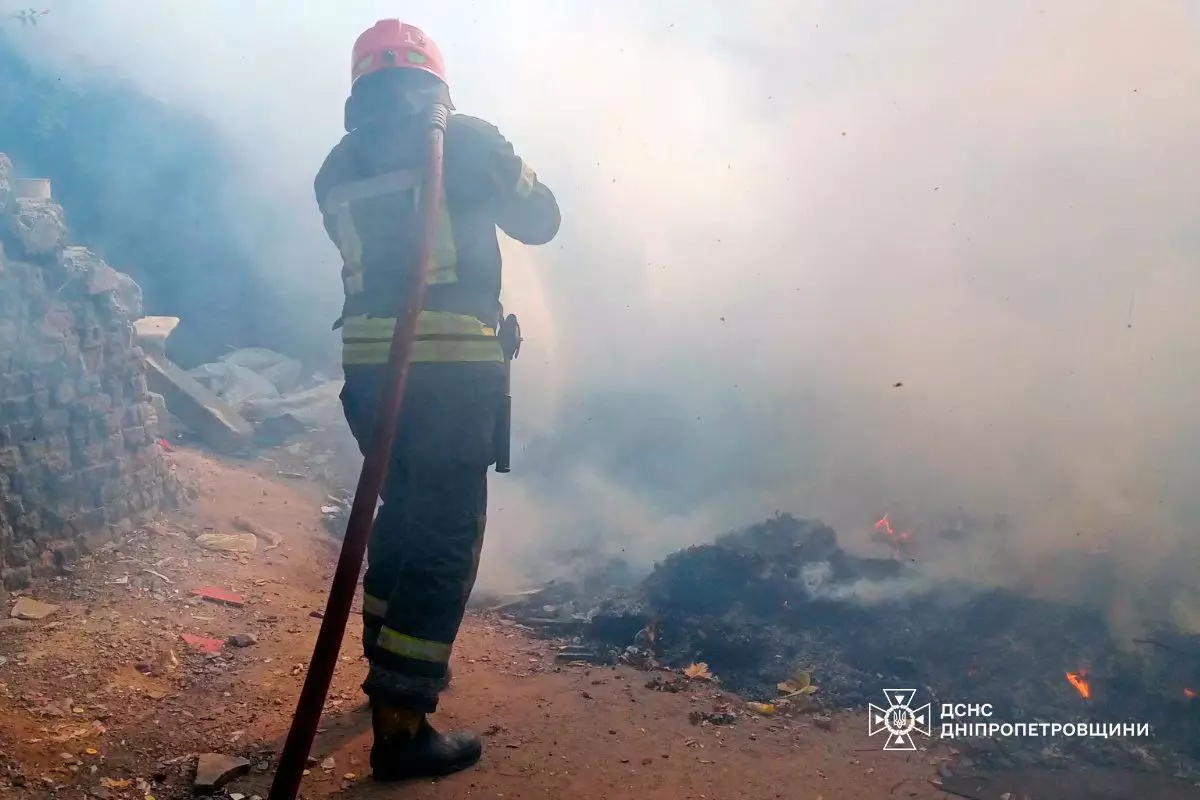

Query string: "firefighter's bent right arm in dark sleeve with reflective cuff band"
[448, 115, 562, 245]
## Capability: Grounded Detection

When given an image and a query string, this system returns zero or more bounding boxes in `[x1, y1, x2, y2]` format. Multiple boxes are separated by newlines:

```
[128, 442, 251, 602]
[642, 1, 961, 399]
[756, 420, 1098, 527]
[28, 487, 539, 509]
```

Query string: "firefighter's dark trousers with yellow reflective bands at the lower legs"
[342, 362, 504, 712]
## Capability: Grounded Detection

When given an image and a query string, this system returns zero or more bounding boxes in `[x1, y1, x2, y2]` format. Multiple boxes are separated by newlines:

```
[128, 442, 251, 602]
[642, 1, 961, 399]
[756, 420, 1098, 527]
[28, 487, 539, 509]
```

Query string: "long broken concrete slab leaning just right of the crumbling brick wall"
[146, 354, 254, 453]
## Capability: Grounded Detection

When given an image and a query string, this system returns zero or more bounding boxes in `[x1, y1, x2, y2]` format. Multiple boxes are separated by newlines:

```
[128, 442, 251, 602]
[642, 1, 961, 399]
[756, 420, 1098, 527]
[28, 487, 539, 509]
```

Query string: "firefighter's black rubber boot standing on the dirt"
[371, 717, 484, 782]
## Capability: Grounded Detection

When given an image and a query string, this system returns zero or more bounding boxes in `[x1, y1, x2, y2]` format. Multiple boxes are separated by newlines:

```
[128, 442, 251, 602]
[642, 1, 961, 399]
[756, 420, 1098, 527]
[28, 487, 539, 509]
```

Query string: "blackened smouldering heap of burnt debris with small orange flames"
[494, 515, 1200, 776]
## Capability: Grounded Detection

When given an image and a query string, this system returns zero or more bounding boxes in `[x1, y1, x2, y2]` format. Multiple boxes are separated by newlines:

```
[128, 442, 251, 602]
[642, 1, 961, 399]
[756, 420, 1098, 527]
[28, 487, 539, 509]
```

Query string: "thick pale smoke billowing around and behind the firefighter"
[20, 0, 1200, 625]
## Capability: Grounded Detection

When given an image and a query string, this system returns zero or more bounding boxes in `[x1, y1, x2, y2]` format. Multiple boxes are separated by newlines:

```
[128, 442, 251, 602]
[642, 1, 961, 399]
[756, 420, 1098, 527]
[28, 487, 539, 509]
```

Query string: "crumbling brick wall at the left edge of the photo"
[0, 154, 174, 590]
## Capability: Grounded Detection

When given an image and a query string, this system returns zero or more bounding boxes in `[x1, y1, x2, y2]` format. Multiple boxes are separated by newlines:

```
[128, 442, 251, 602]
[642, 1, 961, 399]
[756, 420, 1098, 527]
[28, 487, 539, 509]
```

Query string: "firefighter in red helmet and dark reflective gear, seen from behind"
[314, 19, 560, 781]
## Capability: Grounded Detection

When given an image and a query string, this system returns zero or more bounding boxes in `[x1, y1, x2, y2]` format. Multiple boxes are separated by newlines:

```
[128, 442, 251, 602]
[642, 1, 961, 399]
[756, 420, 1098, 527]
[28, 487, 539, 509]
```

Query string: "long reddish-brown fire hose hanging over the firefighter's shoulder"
[268, 104, 451, 800]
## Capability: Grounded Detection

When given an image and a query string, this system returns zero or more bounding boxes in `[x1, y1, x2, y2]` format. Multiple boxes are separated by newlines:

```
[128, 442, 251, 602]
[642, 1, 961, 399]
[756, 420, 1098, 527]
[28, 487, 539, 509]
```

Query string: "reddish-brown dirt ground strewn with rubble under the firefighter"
[0, 451, 950, 800]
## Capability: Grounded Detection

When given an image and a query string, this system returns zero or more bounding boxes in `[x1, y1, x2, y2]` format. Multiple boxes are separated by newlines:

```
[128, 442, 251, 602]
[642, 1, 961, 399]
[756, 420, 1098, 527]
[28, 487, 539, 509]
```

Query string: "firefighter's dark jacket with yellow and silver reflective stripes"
[314, 114, 560, 366]
